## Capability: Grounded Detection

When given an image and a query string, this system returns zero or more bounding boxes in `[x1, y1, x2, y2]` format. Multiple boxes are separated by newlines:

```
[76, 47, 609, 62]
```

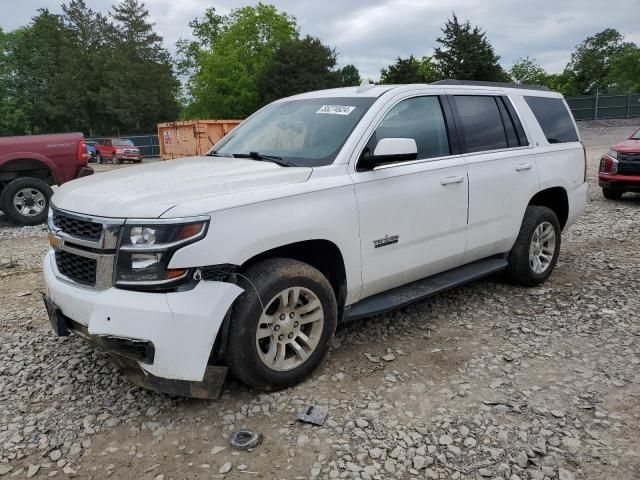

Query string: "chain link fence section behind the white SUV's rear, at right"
[567, 93, 640, 120]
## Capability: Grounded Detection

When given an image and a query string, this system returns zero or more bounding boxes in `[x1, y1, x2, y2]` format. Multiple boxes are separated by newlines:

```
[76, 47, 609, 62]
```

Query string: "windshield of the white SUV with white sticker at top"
[209, 97, 376, 167]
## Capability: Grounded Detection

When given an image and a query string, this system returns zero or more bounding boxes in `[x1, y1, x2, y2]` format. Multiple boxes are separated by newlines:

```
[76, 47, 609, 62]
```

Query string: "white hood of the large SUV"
[51, 157, 312, 218]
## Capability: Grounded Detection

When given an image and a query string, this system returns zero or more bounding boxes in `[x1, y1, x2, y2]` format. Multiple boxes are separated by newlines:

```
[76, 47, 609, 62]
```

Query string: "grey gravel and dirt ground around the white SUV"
[0, 122, 640, 480]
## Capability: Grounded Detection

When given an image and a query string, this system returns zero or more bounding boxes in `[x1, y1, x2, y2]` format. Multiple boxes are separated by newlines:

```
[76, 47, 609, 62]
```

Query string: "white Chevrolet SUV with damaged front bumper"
[44, 81, 587, 397]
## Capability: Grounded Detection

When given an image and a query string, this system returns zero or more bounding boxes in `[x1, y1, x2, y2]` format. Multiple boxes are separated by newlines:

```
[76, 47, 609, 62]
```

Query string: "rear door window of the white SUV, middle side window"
[454, 95, 508, 152]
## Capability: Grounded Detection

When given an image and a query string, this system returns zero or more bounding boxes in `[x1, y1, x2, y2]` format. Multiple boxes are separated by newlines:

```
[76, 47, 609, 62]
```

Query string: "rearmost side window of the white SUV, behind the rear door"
[524, 97, 578, 143]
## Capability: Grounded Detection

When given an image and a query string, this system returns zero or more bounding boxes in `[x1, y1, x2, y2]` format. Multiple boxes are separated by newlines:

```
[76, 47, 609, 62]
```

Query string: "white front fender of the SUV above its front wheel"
[169, 184, 362, 304]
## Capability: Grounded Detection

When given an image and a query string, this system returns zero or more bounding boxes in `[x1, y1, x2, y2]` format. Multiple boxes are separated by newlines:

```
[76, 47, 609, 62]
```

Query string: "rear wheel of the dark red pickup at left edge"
[0, 177, 53, 225]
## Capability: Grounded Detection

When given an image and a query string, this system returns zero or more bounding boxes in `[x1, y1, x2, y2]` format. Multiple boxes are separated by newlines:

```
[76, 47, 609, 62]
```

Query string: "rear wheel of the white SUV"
[507, 205, 562, 287]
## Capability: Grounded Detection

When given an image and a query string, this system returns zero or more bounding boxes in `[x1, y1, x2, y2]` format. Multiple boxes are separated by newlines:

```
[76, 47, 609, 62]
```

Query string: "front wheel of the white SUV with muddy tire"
[226, 258, 338, 391]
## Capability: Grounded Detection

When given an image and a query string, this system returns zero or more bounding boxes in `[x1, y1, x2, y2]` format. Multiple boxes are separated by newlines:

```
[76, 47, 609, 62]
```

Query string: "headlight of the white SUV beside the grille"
[116, 219, 209, 289]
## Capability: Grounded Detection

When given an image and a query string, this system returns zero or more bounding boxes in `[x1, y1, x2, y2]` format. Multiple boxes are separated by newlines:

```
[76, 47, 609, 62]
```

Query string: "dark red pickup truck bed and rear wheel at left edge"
[0, 133, 93, 225]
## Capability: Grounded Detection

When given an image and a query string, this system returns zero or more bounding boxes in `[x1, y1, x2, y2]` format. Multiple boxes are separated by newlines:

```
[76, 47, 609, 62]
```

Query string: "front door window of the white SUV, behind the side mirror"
[374, 97, 449, 159]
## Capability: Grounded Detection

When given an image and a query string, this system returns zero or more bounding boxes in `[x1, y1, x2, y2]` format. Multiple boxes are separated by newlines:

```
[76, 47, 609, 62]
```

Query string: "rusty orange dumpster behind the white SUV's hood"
[158, 120, 242, 160]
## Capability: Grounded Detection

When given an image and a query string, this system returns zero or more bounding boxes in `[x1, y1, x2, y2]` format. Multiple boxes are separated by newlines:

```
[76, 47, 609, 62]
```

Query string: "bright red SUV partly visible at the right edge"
[598, 130, 640, 200]
